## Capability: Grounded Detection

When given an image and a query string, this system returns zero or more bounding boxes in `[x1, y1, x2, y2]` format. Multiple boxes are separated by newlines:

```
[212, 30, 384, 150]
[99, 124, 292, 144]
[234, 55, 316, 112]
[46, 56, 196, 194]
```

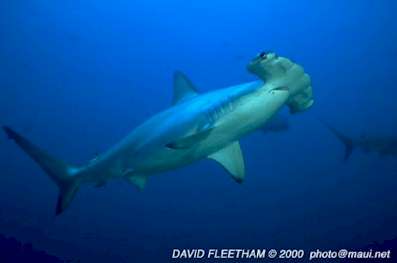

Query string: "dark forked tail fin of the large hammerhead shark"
[3, 127, 80, 215]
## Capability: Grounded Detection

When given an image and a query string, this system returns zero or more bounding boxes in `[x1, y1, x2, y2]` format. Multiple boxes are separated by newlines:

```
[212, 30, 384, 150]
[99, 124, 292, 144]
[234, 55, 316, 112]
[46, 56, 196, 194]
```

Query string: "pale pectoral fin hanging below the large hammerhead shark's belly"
[208, 141, 245, 183]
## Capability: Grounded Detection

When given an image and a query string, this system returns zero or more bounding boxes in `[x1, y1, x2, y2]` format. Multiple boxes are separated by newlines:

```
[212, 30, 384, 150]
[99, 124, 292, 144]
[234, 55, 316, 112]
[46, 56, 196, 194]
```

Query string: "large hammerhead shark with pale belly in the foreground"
[4, 52, 313, 215]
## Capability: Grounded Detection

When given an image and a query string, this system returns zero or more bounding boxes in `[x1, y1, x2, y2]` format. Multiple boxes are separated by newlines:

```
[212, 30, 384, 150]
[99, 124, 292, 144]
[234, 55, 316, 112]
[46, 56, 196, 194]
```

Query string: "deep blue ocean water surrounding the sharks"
[0, 0, 397, 262]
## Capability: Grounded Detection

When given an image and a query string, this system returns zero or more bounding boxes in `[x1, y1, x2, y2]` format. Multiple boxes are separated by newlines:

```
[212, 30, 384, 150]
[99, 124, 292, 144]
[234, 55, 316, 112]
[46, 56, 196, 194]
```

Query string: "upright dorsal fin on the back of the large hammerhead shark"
[172, 71, 198, 105]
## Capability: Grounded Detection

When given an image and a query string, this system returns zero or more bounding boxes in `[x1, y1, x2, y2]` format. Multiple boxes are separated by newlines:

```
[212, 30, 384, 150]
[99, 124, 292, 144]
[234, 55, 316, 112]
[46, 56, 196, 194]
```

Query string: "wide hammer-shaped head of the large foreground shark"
[247, 52, 313, 113]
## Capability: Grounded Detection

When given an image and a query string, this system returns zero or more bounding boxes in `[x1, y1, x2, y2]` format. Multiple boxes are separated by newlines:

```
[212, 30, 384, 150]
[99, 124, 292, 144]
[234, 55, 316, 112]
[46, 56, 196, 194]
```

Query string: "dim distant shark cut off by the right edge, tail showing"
[323, 122, 397, 161]
